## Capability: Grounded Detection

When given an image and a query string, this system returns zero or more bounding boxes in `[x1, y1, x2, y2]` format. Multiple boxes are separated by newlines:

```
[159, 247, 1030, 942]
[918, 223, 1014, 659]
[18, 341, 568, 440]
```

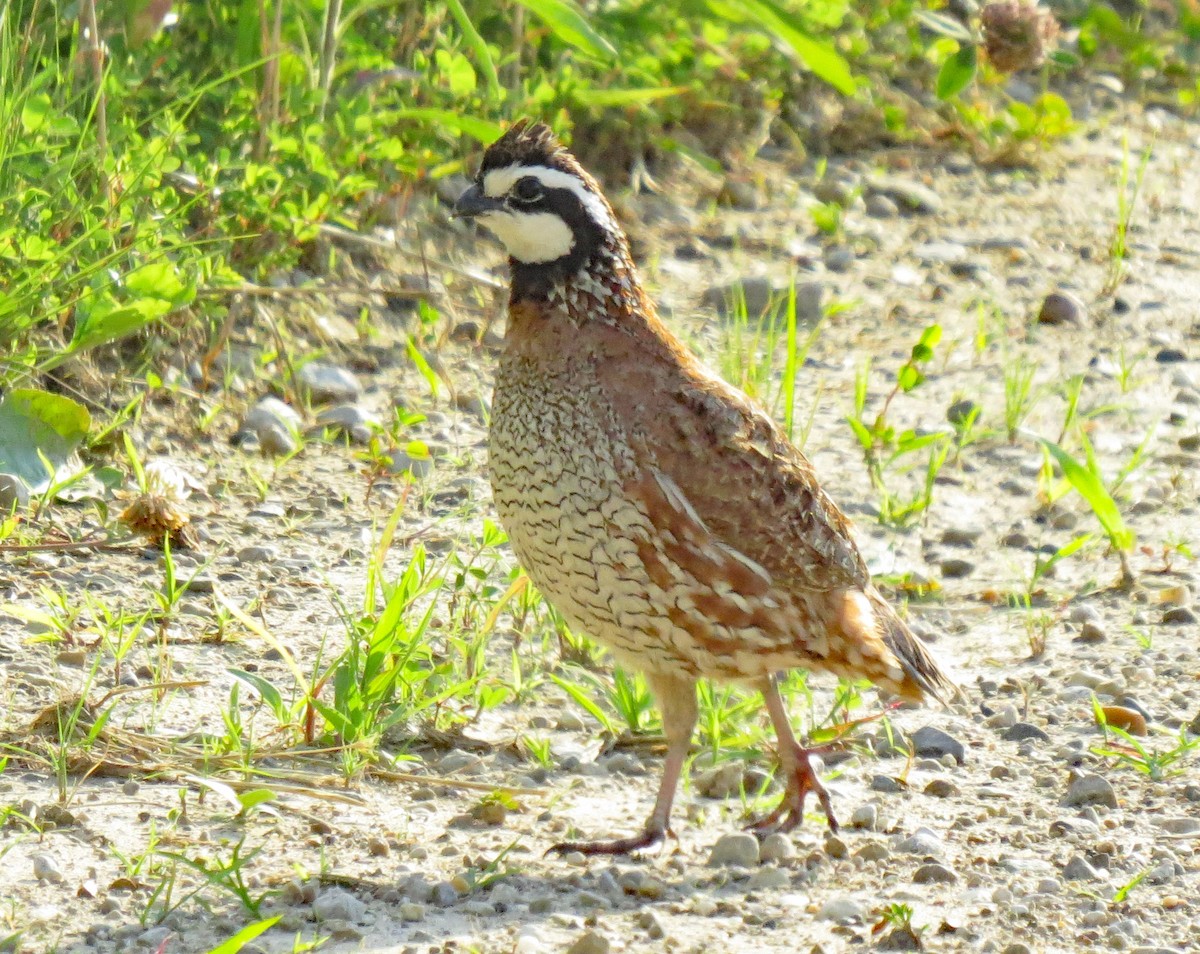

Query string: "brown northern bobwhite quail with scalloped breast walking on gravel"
[456, 121, 954, 854]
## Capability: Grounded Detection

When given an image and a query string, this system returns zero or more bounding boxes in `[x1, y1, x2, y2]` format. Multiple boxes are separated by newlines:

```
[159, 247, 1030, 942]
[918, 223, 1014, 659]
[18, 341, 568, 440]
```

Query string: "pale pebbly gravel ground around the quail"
[0, 102, 1200, 954]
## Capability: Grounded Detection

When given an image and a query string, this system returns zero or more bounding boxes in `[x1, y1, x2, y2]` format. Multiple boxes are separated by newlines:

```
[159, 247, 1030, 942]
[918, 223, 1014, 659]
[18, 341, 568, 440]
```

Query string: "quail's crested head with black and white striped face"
[455, 120, 623, 277]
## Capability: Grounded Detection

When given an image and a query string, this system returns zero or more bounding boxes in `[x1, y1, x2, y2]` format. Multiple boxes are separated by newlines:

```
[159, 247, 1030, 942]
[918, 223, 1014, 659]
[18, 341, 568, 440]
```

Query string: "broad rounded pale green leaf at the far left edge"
[0, 390, 91, 493]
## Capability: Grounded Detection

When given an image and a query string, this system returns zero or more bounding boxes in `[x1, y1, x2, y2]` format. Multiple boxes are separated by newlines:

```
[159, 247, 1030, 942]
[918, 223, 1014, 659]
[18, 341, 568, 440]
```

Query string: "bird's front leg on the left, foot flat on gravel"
[547, 673, 696, 854]
